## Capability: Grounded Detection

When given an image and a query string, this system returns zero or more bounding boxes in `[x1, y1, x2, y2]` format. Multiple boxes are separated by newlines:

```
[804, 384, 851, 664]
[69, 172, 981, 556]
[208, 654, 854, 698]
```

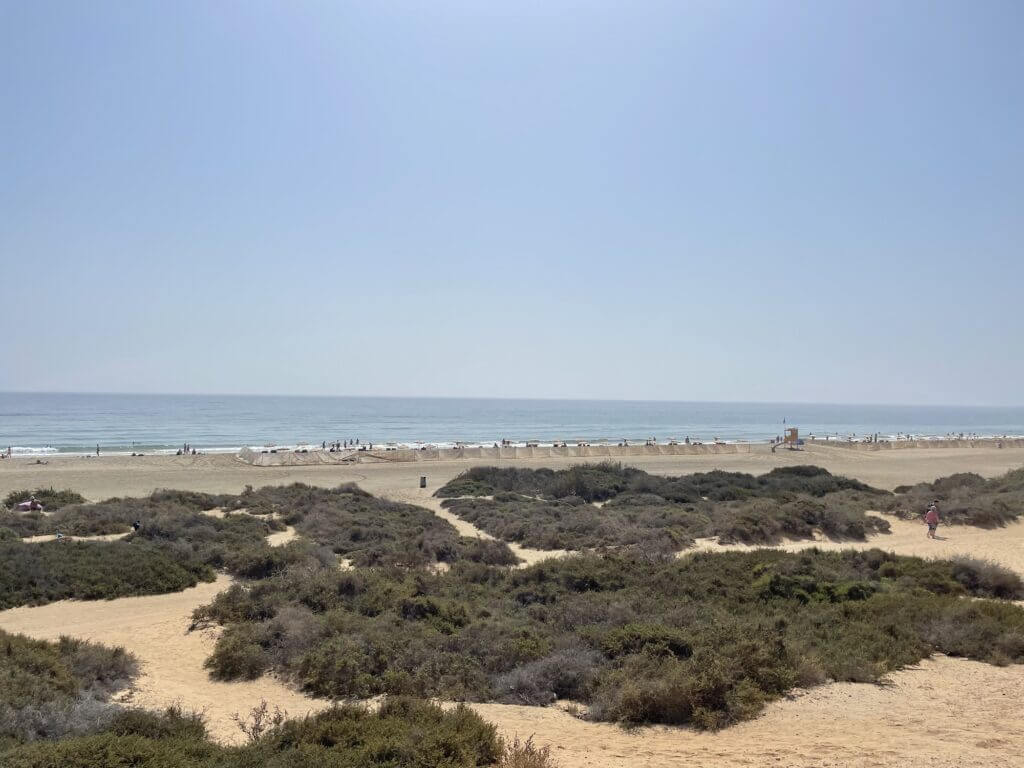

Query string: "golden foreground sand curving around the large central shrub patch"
[0, 561, 1024, 768]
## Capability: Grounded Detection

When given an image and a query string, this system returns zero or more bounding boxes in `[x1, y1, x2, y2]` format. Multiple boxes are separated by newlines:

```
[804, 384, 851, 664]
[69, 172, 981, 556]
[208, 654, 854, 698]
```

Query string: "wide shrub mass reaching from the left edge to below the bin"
[0, 484, 517, 608]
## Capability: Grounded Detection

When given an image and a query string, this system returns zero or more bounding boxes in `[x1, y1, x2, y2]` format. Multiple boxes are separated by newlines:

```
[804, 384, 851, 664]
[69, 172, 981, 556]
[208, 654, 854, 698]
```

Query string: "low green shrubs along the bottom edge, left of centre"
[0, 698, 512, 768]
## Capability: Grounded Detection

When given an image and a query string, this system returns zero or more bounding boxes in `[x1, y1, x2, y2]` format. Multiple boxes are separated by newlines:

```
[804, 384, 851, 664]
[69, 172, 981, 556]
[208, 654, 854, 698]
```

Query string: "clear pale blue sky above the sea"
[0, 0, 1024, 404]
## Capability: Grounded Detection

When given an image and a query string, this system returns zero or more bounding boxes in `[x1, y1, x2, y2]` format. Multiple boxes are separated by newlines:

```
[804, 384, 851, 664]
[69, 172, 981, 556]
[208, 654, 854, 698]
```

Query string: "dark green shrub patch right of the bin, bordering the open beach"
[437, 463, 890, 552]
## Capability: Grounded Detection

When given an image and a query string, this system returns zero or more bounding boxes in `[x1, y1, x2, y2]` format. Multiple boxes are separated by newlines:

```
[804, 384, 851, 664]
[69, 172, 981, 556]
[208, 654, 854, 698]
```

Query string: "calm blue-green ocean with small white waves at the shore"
[0, 392, 1024, 456]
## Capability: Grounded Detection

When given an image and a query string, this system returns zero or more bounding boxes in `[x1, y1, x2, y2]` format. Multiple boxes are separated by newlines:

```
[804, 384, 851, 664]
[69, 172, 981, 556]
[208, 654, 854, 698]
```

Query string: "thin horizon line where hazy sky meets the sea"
[0, 389, 1024, 409]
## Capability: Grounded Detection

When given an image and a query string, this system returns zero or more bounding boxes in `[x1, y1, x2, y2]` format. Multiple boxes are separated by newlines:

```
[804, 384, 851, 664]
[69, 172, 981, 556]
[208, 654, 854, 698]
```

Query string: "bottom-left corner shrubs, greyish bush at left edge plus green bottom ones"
[0, 631, 532, 768]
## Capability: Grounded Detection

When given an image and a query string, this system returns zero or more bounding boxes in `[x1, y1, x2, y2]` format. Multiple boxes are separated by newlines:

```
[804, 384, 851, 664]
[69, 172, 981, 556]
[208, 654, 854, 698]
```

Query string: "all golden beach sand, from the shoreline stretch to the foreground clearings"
[0, 445, 1024, 768]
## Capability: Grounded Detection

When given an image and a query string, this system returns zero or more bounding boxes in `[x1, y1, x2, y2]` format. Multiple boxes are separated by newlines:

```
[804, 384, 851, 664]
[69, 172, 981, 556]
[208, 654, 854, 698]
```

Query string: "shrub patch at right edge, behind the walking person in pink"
[882, 469, 1024, 528]
